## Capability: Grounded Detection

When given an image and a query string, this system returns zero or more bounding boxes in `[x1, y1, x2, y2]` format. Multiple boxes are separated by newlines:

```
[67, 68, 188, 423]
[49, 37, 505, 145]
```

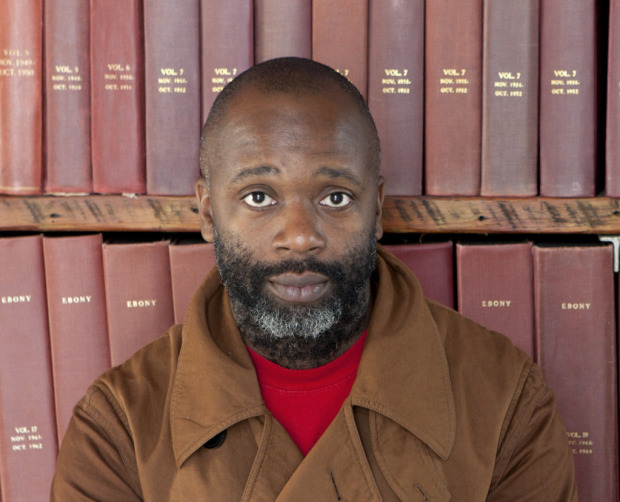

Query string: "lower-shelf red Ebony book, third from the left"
[103, 241, 174, 366]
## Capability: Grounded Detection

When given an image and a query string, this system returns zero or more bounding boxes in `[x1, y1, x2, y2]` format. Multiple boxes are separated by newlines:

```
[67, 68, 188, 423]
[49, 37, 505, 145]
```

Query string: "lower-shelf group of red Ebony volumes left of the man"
[0, 234, 215, 502]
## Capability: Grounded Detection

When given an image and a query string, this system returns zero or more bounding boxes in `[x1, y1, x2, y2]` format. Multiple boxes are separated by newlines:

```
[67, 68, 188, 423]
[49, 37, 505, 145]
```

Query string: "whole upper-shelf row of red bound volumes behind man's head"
[0, 0, 620, 197]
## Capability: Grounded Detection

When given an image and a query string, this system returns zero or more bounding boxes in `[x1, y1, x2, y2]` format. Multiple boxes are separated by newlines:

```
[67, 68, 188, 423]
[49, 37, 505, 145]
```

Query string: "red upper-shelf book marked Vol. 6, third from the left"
[90, 0, 146, 193]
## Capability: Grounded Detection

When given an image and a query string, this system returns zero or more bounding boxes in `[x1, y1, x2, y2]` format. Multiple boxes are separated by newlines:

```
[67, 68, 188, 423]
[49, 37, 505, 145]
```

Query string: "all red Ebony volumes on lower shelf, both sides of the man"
[0, 234, 618, 502]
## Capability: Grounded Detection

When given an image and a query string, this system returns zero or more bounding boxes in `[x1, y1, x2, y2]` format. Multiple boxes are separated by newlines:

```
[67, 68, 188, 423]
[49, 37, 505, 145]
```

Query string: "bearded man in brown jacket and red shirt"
[52, 58, 577, 502]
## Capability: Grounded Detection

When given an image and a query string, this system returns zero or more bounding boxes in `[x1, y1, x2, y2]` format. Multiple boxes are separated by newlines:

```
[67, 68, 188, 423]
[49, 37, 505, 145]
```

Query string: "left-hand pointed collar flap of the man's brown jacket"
[170, 269, 267, 467]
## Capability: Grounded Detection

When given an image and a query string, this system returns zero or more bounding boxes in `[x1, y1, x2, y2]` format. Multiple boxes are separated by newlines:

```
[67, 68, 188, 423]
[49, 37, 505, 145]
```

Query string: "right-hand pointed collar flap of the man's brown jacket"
[351, 248, 456, 459]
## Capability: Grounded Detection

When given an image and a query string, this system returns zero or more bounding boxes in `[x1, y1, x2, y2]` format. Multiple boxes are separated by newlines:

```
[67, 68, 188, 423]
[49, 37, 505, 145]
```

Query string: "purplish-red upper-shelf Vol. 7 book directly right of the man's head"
[368, 0, 424, 196]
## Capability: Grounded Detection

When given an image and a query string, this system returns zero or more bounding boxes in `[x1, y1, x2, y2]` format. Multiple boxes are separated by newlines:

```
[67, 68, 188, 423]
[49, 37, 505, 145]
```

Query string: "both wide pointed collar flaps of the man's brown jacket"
[170, 247, 456, 467]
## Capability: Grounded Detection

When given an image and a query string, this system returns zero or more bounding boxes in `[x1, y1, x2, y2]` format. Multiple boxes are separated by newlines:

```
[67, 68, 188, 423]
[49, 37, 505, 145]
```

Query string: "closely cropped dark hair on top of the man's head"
[200, 57, 381, 184]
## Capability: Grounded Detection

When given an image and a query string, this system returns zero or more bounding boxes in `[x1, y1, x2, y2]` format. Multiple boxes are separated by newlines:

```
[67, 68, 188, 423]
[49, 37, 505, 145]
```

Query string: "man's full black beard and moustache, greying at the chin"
[214, 229, 376, 368]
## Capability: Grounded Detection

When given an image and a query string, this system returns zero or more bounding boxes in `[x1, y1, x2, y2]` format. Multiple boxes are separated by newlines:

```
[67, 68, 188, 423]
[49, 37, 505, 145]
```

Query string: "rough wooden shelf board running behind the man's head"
[0, 195, 620, 234]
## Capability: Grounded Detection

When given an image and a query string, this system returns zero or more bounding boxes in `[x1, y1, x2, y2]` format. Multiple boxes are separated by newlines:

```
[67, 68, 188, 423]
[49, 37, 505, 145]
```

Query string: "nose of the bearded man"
[273, 203, 325, 254]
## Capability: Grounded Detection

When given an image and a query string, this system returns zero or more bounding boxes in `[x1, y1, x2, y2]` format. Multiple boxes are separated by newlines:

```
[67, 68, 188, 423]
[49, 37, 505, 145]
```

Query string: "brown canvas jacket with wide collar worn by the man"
[52, 249, 577, 502]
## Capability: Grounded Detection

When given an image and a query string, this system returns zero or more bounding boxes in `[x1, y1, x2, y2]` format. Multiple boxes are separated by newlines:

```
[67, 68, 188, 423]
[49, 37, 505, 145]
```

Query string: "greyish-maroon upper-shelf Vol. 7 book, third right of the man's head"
[480, 0, 540, 196]
